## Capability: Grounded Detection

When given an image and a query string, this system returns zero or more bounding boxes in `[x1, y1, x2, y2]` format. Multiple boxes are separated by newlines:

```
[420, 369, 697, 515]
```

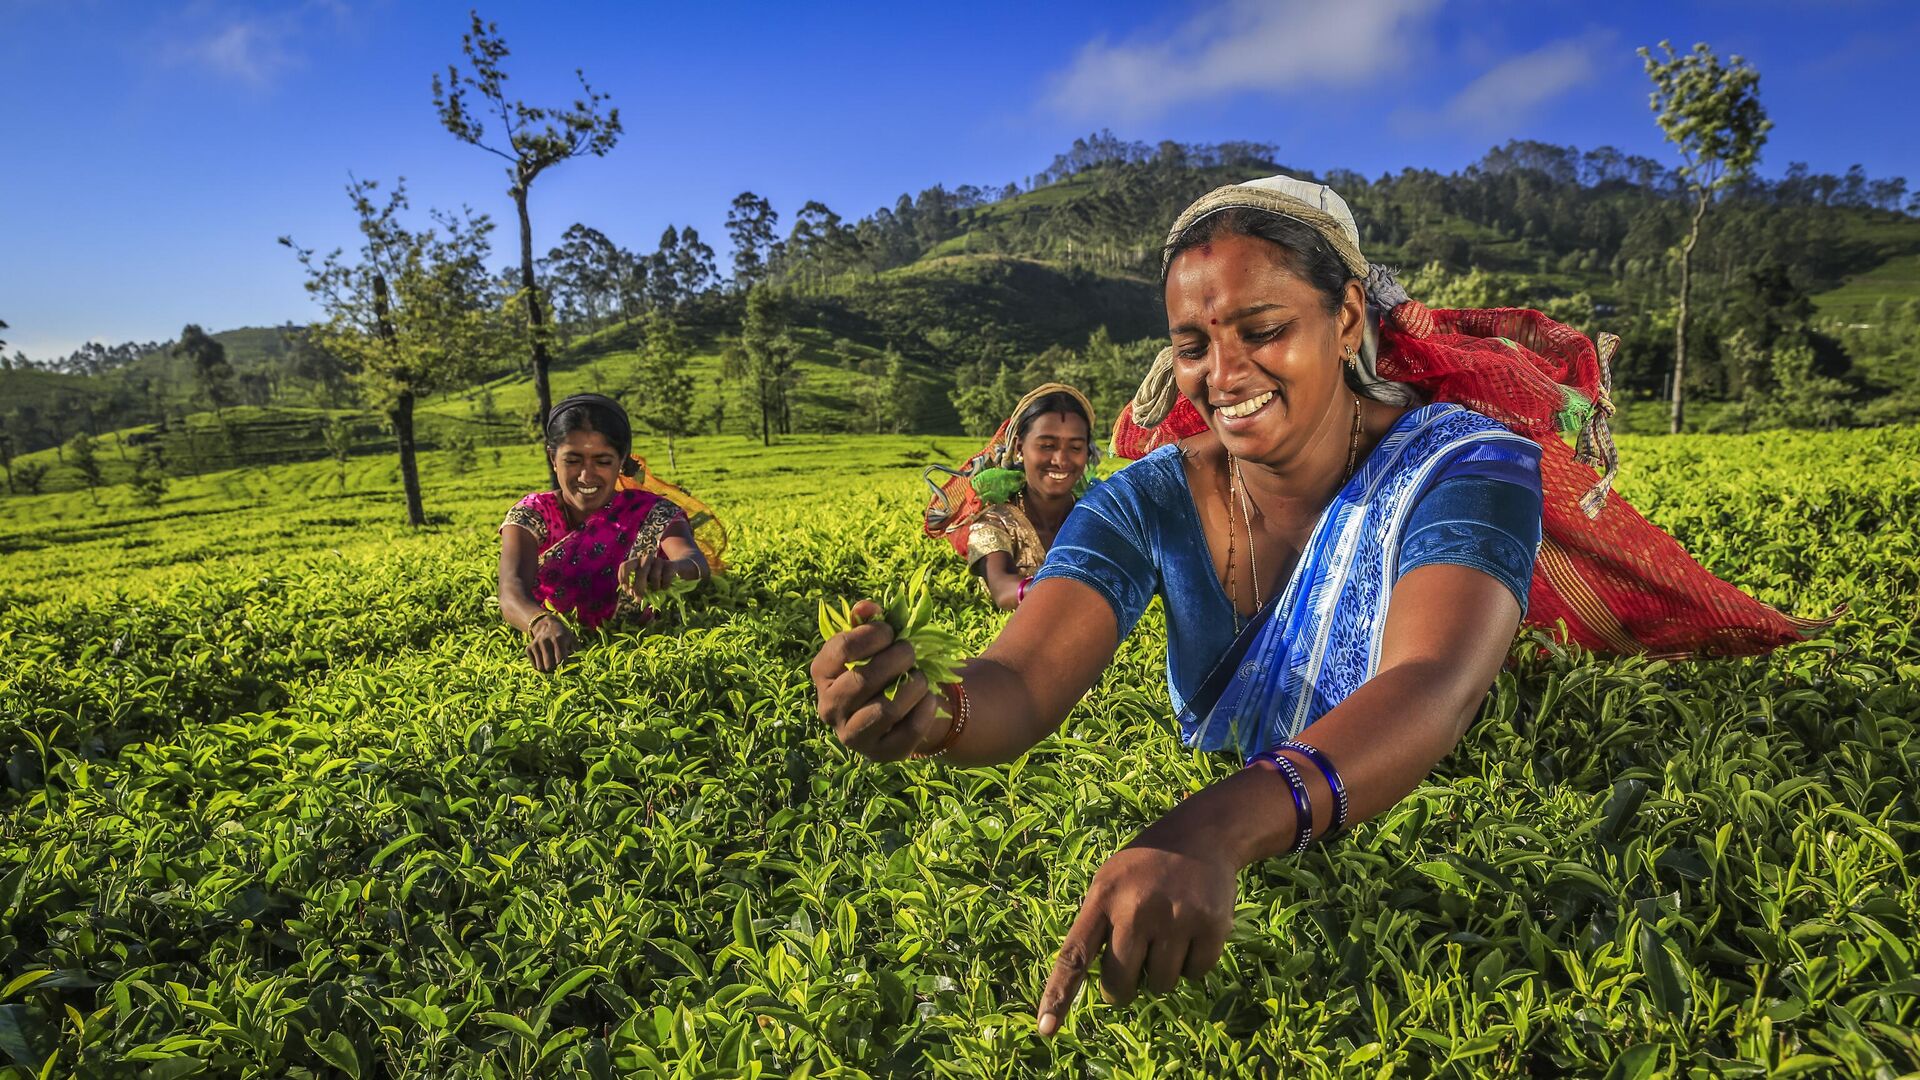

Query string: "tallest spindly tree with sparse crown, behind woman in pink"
[434, 12, 620, 440]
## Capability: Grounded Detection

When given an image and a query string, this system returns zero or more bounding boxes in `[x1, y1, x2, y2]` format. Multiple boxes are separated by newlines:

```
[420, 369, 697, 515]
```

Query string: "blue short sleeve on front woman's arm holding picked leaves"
[1033, 455, 1181, 640]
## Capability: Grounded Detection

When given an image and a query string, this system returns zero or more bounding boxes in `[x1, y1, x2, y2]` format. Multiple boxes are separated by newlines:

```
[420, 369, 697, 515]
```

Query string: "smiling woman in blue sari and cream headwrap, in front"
[812, 177, 1540, 1034]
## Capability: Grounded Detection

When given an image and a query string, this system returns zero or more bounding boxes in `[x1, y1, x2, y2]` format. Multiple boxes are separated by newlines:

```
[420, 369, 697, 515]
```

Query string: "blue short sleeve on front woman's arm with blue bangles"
[1400, 432, 1542, 615]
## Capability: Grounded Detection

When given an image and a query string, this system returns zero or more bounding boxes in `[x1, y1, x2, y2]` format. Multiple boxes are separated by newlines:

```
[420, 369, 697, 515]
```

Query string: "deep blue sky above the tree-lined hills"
[0, 0, 1920, 359]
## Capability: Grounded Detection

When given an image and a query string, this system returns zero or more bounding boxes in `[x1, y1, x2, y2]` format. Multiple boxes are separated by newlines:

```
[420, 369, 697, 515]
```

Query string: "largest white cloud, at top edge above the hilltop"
[1046, 0, 1438, 119]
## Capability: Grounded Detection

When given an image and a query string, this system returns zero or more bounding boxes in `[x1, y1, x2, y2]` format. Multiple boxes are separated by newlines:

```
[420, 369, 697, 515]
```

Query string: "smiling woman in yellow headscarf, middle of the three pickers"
[925, 382, 1098, 611]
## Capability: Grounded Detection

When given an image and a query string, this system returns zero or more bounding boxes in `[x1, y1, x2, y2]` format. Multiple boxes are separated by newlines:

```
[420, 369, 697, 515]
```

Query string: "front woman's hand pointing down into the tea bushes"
[1039, 826, 1240, 1036]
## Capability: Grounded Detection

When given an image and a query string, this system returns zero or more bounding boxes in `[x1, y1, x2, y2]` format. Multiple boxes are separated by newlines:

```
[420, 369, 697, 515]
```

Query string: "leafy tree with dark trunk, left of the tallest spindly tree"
[280, 181, 505, 527]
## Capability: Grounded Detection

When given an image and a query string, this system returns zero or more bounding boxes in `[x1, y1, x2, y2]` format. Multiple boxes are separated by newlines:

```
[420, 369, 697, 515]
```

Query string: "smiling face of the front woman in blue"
[1167, 233, 1365, 465]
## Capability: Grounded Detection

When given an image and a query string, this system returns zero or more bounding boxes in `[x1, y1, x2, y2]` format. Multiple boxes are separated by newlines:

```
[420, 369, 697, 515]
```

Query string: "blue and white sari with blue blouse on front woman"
[1037, 404, 1540, 757]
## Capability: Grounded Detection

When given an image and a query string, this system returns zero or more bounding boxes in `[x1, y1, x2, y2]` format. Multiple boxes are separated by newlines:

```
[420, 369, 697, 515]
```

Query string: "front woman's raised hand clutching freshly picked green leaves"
[808, 600, 952, 761]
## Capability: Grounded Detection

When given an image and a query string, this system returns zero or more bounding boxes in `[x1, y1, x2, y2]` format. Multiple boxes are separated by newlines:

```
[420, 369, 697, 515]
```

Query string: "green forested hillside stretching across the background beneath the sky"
[0, 135, 1920, 484]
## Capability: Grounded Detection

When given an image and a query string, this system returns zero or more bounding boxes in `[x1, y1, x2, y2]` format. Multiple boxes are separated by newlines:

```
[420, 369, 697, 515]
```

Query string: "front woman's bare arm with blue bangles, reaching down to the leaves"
[1008, 565, 1521, 1036]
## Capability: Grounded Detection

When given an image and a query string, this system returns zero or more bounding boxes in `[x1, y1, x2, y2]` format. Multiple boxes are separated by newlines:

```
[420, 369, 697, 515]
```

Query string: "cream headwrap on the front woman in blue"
[1133, 177, 1417, 427]
